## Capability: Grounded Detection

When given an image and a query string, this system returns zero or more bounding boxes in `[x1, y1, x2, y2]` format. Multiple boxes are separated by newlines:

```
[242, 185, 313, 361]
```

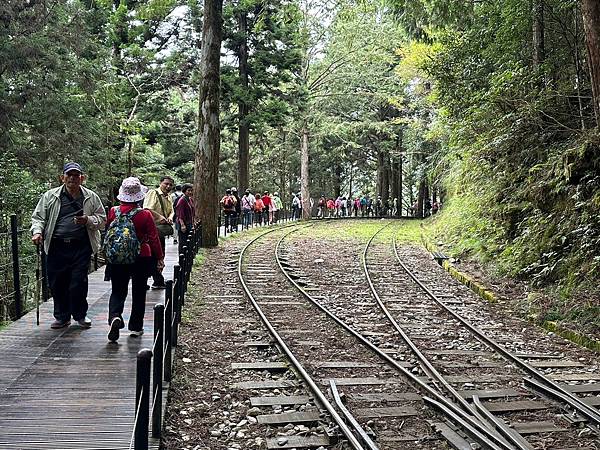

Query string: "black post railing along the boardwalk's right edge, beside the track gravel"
[130, 225, 202, 450]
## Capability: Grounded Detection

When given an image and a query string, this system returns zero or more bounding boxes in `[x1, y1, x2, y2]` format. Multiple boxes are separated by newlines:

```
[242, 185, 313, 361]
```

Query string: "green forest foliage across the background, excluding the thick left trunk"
[0, 0, 600, 314]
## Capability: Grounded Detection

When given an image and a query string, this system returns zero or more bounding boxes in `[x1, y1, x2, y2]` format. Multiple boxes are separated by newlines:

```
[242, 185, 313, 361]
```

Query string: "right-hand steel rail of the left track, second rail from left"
[275, 225, 514, 450]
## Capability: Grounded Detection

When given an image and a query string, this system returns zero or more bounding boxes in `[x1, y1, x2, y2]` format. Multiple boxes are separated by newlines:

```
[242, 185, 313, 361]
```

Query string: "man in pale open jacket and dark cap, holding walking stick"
[31, 162, 106, 329]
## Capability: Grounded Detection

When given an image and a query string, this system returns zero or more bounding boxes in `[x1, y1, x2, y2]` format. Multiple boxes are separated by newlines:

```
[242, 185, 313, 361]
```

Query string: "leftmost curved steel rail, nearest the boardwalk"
[237, 225, 364, 450]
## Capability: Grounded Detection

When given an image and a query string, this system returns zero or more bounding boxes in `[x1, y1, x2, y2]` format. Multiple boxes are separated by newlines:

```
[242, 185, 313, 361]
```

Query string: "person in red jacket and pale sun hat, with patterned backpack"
[103, 177, 165, 342]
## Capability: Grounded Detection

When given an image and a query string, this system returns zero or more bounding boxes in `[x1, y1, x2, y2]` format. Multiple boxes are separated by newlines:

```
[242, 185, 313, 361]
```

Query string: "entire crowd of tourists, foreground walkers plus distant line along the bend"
[31, 162, 441, 342]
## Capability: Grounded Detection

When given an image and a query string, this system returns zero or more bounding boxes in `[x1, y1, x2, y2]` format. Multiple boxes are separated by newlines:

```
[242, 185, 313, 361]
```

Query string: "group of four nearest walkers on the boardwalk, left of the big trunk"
[31, 162, 195, 342]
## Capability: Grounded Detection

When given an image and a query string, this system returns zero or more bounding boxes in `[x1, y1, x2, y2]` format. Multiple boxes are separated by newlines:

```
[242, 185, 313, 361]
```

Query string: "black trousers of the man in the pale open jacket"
[46, 239, 92, 322]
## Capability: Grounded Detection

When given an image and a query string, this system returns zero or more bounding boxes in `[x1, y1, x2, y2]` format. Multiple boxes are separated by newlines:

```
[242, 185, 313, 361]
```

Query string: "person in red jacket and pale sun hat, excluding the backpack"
[106, 177, 165, 342]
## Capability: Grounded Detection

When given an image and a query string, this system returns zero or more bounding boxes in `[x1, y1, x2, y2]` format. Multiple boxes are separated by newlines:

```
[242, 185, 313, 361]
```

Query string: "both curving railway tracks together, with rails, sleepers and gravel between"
[220, 222, 600, 450]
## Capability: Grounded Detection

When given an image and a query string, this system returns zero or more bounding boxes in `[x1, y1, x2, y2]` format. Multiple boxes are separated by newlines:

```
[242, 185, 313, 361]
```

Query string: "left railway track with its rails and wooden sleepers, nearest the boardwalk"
[232, 224, 536, 449]
